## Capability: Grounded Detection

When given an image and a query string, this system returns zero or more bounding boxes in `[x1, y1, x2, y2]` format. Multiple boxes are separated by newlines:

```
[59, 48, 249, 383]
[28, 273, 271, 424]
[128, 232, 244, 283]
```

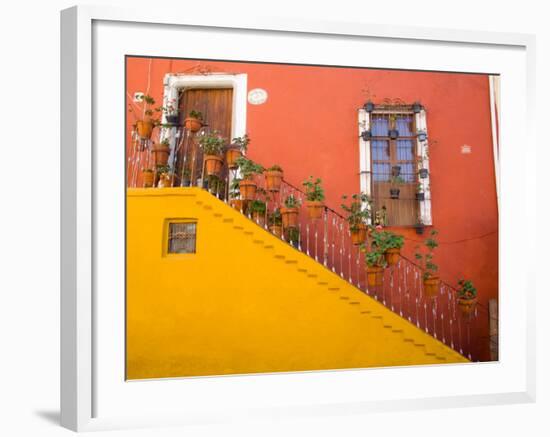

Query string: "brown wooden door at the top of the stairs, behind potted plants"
[176, 88, 233, 185]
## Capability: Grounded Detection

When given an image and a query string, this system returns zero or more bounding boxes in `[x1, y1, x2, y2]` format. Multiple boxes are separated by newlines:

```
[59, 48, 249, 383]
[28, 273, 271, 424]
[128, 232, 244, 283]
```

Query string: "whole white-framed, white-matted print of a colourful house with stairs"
[62, 7, 534, 430]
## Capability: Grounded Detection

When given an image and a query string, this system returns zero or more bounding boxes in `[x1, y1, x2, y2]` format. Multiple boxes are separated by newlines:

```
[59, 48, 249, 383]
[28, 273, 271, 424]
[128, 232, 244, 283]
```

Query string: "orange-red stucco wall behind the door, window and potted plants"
[127, 58, 498, 358]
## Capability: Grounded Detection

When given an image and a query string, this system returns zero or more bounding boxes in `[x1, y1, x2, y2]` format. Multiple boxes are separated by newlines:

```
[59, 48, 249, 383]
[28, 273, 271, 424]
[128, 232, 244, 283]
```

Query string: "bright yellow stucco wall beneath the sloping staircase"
[127, 188, 467, 379]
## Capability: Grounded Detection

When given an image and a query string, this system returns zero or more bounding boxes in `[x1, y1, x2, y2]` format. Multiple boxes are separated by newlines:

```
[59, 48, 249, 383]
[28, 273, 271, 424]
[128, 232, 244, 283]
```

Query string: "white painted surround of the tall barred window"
[358, 108, 432, 226]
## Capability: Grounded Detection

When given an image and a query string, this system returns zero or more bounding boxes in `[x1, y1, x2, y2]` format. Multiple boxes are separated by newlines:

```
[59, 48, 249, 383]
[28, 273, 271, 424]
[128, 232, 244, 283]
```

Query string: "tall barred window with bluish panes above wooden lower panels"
[369, 110, 419, 226]
